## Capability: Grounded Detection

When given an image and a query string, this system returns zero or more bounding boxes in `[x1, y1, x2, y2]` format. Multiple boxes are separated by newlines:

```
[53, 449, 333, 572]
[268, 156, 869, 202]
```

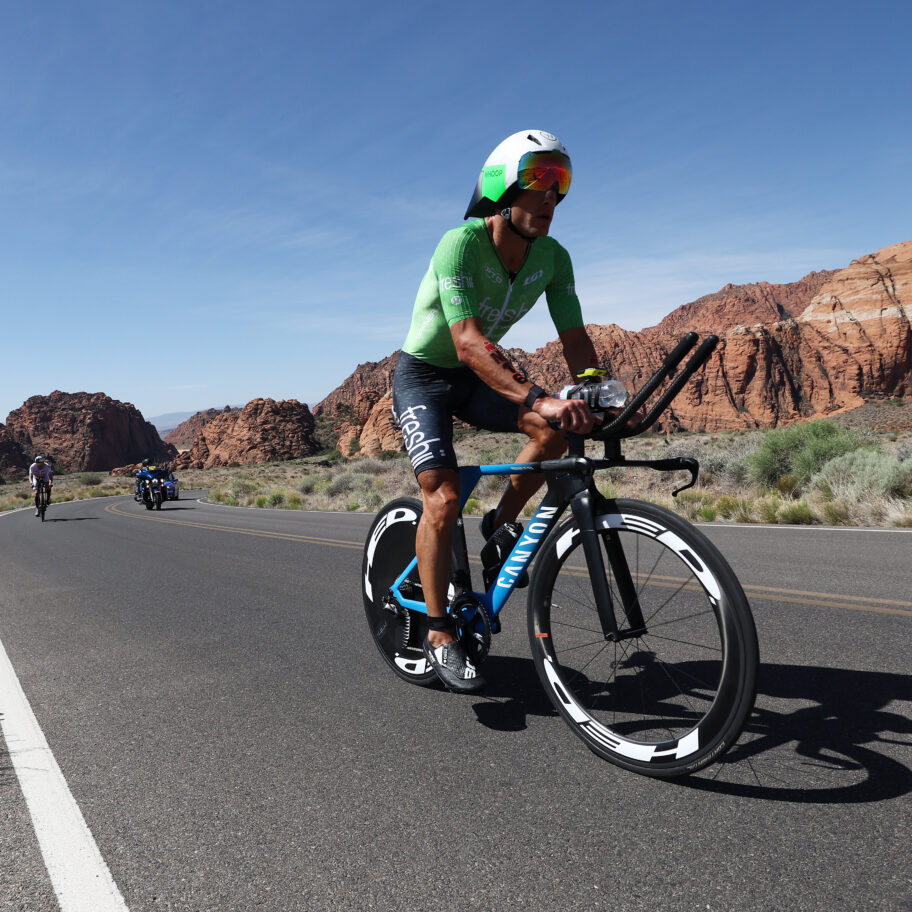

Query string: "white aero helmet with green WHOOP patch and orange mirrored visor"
[463, 130, 572, 218]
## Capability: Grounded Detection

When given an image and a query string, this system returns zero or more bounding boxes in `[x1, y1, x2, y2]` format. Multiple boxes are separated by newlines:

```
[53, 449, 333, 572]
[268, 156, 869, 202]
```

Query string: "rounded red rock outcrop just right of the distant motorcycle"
[172, 399, 319, 469]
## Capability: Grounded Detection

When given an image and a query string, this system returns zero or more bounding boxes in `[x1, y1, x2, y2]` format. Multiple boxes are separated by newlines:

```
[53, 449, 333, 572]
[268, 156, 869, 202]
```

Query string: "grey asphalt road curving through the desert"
[0, 495, 912, 912]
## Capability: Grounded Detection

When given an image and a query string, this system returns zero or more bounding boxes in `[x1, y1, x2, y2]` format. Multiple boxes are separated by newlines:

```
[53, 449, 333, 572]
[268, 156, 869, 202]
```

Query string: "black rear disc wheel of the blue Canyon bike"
[361, 497, 438, 686]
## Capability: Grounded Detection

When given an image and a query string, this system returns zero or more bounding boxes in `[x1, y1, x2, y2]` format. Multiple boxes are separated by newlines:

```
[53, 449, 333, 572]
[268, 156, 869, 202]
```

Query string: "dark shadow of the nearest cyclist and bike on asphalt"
[473, 656, 912, 804]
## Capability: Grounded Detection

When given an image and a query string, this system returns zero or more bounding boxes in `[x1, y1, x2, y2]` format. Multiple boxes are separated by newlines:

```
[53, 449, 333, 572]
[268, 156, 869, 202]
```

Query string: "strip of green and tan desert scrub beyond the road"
[0, 420, 912, 527]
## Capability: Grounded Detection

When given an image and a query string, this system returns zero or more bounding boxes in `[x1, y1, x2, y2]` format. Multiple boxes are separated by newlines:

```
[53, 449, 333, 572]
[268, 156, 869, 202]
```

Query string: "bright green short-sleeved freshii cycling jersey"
[402, 219, 583, 367]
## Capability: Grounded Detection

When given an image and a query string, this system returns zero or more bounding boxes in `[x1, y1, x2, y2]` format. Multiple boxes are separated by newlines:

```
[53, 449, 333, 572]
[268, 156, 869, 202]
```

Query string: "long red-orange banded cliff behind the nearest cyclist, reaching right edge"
[314, 241, 912, 454]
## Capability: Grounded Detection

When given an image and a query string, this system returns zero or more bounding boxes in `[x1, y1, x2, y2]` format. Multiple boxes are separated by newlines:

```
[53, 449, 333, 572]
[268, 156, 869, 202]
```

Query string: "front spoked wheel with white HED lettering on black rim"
[528, 500, 759, 778]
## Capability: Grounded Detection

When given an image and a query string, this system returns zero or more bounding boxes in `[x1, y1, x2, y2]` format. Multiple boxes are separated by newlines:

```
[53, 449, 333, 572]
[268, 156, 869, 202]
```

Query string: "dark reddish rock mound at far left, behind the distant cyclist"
[6, 390, 177, 472]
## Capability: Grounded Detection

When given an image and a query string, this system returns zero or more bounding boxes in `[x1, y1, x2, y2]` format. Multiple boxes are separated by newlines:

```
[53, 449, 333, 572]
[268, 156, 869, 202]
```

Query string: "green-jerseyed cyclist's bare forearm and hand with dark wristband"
[450, 317, 592, 434]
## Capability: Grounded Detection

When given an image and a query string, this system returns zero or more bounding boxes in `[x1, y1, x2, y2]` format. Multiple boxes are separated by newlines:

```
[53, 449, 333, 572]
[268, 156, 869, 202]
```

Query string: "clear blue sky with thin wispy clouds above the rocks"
[0, 0, 912, 421]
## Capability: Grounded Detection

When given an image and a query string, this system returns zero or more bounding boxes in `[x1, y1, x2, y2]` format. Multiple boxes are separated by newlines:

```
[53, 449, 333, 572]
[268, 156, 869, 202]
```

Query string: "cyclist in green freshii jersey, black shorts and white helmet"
[393, 130, 598, 692]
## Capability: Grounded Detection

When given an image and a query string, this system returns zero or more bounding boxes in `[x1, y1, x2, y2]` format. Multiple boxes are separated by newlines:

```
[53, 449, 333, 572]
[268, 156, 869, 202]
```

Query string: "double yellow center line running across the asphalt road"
[105, 504, 912, 618]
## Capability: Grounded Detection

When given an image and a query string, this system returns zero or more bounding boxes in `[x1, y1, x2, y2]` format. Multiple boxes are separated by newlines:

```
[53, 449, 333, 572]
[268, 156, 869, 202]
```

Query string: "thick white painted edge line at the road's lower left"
[0, 642, 129, 912]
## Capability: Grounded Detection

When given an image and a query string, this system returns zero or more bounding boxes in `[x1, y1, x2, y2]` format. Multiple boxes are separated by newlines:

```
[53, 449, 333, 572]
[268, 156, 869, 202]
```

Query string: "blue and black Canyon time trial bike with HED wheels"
[362, 333, 759, 778]
